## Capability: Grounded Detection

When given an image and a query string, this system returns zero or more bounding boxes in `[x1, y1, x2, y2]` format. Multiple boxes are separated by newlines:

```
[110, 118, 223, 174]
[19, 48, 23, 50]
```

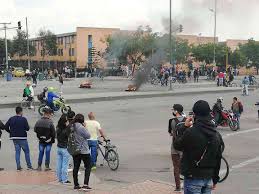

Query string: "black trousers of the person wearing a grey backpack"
[73, 154, 91, 186]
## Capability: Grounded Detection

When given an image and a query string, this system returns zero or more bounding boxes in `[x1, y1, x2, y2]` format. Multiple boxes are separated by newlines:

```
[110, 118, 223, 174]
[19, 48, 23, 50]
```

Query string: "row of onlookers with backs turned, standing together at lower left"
[0, 106, 105, 191]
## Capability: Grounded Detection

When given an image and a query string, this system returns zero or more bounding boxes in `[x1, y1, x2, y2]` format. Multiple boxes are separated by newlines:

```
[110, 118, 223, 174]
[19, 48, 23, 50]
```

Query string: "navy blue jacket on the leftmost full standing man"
[5, 115, 30, 139]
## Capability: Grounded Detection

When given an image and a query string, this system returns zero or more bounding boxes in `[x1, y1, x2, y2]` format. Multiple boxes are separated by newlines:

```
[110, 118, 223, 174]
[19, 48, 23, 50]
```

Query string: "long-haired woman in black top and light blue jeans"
[56, 114, 71, 184]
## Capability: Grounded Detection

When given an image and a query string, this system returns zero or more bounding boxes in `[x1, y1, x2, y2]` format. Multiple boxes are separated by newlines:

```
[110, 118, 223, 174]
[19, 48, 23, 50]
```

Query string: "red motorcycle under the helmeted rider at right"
[212, 110, 238, 131]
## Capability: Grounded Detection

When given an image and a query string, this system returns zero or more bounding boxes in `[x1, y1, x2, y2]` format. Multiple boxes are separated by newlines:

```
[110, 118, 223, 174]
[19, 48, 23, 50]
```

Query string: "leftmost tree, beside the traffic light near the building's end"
[11, 30, 36, 57]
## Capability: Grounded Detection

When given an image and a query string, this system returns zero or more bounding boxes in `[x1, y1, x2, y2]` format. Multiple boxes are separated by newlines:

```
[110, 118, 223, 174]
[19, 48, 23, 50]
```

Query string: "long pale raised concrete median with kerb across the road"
[0, 87, 241, 108]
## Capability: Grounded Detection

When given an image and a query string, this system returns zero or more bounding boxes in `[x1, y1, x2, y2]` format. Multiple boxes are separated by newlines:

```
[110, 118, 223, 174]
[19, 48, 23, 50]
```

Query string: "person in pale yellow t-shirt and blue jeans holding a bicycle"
[85, 112, 104, 170]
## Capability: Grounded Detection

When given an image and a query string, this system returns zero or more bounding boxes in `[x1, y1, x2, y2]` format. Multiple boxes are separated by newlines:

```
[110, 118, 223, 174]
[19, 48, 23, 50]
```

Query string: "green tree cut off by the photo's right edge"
[239, 39, 259, 74]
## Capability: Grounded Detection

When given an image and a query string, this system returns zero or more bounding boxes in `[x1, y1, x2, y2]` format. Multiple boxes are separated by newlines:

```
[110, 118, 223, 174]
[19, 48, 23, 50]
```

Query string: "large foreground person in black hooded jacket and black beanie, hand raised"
[174, 100, 224, 194]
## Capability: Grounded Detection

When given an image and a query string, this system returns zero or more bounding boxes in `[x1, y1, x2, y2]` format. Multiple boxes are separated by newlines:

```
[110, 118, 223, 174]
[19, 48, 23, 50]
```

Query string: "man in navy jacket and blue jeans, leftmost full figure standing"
[5, 106, 33, 171]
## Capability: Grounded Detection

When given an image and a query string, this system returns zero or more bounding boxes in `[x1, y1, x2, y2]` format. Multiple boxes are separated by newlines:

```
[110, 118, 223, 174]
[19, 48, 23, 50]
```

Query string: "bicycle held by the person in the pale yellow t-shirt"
[97, 138, 119, 171]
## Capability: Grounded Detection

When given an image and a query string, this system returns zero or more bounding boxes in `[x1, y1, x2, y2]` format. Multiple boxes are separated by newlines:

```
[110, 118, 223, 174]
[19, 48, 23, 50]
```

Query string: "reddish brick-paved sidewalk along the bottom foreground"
[0, 171, 178, 194]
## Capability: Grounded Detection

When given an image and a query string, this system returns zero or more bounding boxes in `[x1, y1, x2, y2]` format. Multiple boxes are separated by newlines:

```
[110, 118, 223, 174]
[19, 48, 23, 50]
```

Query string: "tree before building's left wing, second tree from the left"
[39, 29, 57, 58]
